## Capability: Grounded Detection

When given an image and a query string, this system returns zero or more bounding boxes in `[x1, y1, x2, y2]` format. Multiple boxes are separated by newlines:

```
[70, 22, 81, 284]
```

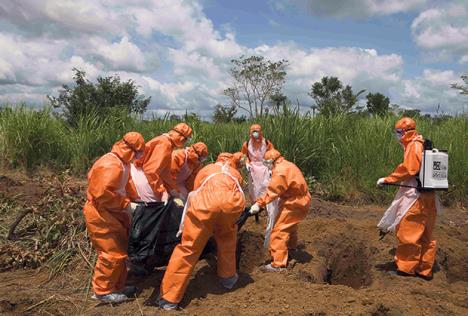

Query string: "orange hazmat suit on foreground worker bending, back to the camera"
[160, 153, 245, 303]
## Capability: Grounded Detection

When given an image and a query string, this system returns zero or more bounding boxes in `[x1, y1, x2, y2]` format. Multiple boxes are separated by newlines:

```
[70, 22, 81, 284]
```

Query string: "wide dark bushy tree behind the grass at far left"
[47, 68, 151, 125]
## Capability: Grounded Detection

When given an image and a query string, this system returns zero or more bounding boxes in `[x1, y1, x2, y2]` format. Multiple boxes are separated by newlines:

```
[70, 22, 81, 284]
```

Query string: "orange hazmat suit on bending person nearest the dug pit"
[257, 149, 311, 268]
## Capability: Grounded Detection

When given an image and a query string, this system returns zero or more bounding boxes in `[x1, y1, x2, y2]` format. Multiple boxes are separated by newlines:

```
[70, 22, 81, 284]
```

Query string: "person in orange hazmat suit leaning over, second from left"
[131, 123, 192, 202]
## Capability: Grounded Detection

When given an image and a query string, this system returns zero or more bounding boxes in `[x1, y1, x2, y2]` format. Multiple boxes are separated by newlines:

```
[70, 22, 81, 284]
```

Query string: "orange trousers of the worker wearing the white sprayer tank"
[395, 193, 437, 276]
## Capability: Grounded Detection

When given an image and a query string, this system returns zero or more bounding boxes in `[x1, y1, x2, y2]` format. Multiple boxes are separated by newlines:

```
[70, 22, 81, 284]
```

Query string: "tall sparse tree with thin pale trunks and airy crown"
[224, 56, 288, 118]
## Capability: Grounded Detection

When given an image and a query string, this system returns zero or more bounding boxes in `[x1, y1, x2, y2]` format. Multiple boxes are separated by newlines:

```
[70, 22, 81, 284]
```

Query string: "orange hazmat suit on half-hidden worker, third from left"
[169, 142, 208, 200]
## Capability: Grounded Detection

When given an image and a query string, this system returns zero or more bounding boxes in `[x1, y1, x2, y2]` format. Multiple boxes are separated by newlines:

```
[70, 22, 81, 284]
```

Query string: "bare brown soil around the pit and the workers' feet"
[0, 175, 468, 315]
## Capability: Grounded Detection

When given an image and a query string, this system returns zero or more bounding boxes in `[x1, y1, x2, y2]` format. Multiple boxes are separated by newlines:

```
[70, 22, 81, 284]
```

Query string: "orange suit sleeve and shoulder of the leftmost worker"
[88, 163, 130, 212]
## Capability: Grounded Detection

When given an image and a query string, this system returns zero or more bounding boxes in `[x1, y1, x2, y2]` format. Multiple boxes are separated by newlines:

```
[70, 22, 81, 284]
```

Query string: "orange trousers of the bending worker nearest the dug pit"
[269, 203, 310, 267]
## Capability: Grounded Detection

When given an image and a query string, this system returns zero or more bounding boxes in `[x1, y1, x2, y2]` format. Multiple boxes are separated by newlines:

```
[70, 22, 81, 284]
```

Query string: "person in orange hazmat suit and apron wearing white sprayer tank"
[377, 117, 440, 280]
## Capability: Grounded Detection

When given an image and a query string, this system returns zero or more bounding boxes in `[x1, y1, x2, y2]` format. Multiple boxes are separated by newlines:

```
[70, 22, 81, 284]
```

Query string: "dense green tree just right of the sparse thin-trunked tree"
[309, 77, 365, 116]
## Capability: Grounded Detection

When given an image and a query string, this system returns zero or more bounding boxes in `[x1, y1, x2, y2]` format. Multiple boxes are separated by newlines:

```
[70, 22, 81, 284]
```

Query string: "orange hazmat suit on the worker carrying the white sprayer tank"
[384, 118, 437, 277]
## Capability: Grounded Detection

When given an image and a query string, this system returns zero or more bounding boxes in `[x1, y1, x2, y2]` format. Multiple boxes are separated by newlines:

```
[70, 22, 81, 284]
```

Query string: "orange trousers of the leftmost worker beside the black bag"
[83, 202, 128, 295]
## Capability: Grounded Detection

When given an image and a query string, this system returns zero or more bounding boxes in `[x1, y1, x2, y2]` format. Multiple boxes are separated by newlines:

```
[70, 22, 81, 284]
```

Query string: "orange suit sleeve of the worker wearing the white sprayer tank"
[385, 141, 423, 183]
